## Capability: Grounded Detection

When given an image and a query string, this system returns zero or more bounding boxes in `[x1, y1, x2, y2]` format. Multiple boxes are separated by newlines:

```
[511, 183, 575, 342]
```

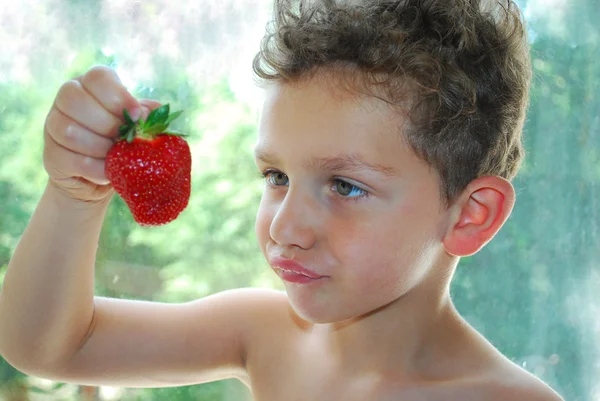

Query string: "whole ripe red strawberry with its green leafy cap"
[105, 104, 192, 226]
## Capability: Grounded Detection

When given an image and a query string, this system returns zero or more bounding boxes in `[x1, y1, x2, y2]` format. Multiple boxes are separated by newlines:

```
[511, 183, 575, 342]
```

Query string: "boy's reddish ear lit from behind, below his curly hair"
[442, 176, 515, 256]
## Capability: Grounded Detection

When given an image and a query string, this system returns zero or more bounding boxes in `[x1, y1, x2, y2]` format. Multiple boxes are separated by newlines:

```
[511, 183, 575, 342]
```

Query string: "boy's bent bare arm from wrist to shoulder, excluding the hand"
[0, 185, 284, 387]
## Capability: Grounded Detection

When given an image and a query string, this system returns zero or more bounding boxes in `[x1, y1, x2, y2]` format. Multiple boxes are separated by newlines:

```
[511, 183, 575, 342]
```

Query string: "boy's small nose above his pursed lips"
[269, 190, 318, 249]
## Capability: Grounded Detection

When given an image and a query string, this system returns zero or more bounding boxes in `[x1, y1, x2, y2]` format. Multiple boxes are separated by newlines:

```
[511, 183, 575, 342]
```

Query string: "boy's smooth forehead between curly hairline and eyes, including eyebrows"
[255, 84, 422, 177]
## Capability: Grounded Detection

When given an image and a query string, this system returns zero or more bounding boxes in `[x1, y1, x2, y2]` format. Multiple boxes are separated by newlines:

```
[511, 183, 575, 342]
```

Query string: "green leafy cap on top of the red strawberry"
[119, 103, 187, 143]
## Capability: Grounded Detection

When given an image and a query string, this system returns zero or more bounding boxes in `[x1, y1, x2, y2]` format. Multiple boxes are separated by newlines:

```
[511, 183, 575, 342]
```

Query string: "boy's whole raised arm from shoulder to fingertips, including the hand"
[0, 67, 279, 387]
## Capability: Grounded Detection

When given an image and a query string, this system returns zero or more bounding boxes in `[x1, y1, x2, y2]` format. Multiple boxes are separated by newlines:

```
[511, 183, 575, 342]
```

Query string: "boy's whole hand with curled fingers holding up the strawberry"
[44, 66, 159, 201]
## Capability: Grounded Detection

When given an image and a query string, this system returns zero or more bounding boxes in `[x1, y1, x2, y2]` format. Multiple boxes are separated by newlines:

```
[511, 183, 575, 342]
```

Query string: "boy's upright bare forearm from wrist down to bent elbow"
[0, 182, 110, 370]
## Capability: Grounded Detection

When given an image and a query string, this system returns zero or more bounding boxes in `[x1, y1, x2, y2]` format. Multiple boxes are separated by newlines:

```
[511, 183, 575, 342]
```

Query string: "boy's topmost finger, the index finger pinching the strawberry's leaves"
[80, 66, 140, 121]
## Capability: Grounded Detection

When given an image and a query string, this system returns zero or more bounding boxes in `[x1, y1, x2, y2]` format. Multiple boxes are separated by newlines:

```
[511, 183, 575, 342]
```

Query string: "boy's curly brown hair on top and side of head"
[253, 0, 531, 205]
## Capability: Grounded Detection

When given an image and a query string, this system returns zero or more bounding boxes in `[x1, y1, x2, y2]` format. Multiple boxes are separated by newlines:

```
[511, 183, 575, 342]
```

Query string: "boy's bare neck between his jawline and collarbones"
[313, 260, 469, 378]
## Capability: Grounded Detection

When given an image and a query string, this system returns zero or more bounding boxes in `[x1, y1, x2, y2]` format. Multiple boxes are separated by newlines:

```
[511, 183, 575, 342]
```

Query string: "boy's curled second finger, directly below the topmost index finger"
[54, 80, 122, 138]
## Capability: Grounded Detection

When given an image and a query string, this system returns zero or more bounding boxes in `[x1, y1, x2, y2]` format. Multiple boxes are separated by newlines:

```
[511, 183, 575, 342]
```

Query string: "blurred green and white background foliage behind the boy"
[0, 0, 600, 401]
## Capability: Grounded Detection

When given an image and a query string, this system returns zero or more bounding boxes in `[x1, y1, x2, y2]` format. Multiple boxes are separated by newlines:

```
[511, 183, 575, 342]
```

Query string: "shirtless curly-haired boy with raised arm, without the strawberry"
[0, 0, 561, 401]
